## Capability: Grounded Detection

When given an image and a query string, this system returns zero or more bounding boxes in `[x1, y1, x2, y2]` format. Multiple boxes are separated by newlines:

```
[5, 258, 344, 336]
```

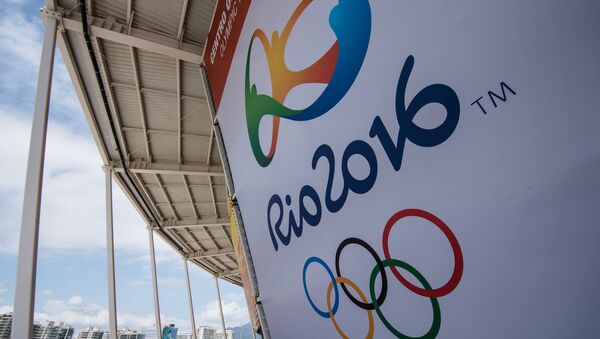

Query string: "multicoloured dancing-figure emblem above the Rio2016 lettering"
[245, 0, 371, 167]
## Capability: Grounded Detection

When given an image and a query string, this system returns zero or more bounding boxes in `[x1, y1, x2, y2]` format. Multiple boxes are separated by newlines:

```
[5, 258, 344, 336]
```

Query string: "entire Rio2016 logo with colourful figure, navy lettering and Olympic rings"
[245, 0, 463, 338]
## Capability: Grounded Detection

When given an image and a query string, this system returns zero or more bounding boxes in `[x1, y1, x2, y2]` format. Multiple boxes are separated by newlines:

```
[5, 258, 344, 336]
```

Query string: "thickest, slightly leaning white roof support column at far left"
[12, 17, 58, 338]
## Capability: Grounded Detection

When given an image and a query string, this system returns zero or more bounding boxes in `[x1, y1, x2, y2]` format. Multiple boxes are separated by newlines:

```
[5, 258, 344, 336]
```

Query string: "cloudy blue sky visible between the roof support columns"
[0, 0, 248, 330]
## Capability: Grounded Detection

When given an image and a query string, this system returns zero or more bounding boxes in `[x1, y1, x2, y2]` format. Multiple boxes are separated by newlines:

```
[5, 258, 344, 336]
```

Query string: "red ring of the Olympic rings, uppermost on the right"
[382, 209, 463, 298]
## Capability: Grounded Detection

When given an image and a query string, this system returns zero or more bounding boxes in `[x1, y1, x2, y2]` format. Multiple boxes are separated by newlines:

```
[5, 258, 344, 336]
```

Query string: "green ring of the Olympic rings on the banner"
[369, 259, 442, 339]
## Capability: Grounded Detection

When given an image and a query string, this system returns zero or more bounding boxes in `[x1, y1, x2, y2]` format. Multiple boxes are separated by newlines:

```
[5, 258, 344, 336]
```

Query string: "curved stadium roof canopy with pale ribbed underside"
[43, 0, 241, 285]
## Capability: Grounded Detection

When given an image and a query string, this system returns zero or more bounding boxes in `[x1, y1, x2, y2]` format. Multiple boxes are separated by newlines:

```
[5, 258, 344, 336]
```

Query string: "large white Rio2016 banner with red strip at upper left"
[204, 0, 600, 338]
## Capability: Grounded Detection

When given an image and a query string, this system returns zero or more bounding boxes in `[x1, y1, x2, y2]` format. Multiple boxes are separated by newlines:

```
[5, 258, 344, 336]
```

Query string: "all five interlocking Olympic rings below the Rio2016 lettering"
[302, 209, 464, 339]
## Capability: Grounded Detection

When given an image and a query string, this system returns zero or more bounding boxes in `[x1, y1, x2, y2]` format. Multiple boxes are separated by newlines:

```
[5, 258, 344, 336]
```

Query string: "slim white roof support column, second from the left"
[104, 167, 117, 339]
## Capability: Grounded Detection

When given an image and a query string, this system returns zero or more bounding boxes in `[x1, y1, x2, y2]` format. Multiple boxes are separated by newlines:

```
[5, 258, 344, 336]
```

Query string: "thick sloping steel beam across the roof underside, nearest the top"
[62, 12, 203, 65]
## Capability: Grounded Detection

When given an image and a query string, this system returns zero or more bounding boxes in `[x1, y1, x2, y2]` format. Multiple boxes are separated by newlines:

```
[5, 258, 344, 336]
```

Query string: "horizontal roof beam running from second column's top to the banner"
[114, 161, 225, 177]
